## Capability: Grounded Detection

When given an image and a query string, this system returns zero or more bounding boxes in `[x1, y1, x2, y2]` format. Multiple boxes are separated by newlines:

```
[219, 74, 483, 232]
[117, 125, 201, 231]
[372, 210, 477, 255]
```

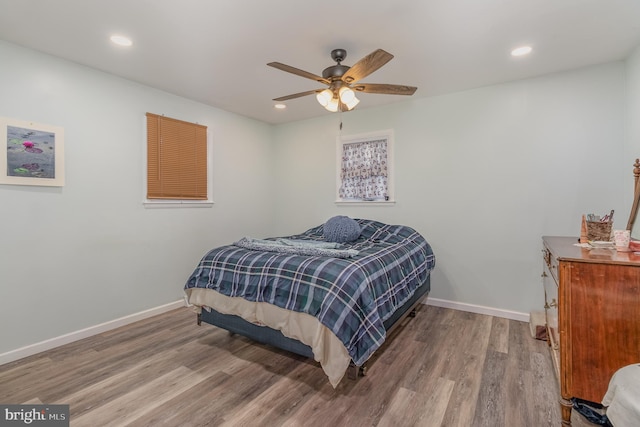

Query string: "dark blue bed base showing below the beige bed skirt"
[197, 275, 431, 379]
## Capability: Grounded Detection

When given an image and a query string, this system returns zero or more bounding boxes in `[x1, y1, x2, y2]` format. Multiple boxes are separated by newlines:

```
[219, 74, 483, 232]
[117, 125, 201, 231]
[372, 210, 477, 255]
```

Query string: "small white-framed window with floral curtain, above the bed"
[336, 130, 394, 203]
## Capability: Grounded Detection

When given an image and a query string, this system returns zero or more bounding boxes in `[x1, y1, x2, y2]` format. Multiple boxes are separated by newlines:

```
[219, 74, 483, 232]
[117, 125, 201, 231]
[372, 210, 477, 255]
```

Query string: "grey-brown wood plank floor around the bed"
[0, 306, 593, 427]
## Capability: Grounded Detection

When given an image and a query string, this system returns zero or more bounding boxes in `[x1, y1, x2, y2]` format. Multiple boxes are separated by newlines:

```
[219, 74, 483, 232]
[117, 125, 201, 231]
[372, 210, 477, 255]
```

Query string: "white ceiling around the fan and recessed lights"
[0, 0, 640, 123]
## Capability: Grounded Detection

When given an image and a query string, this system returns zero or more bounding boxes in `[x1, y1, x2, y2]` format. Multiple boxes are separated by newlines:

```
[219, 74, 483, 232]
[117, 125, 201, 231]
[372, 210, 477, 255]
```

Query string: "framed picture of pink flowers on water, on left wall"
[0, 117, 64, 187]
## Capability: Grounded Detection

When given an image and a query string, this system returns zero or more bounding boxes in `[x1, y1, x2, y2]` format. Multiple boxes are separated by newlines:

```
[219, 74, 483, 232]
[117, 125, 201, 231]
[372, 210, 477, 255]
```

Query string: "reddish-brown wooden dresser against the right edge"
[542, 236, 640, 425]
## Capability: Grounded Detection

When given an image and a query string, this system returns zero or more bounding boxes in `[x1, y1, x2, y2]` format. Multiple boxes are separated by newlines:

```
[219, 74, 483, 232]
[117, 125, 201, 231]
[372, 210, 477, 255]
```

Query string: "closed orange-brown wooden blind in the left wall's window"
[147, 113, 207, 200]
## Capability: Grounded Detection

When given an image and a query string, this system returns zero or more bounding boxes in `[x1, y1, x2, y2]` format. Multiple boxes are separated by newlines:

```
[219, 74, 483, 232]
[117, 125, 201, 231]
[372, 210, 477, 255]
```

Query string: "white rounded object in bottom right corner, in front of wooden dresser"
[602, 363, 640, 427]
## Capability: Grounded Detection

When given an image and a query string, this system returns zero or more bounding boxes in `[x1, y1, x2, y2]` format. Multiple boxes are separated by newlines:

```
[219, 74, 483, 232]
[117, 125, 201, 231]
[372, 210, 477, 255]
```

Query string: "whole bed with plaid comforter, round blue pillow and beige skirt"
[184, 216, 435, 387]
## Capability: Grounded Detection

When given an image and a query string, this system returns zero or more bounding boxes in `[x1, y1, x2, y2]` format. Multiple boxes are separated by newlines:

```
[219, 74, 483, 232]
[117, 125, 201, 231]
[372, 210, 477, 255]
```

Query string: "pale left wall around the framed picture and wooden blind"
[0, 42, 273, 354]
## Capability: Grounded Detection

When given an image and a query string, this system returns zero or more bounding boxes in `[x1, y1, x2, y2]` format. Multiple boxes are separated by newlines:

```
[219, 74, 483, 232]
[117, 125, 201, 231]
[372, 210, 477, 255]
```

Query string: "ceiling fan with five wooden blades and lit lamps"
[267, 49, 418, 112]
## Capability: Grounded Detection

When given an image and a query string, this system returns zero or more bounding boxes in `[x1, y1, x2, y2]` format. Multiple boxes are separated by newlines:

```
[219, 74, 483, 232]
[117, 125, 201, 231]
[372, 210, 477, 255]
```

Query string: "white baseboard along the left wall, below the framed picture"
[0, 299, 185, 365]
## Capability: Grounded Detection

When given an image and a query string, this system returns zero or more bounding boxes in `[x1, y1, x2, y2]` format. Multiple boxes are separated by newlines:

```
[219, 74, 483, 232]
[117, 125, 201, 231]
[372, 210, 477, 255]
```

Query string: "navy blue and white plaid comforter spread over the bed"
[185, 219, 435, 366]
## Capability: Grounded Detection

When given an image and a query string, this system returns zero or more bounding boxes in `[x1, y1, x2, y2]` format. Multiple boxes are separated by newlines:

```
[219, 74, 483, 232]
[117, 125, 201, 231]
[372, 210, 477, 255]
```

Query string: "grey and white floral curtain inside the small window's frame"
[339, 139, 388, 200]
